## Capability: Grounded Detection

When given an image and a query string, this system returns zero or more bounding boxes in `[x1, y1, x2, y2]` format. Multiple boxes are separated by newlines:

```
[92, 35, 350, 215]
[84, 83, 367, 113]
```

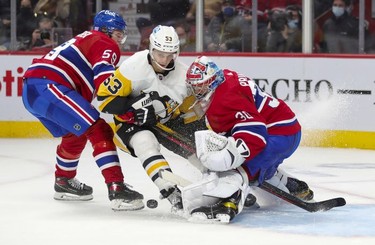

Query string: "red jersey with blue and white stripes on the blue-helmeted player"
[24, 31, 120, 102]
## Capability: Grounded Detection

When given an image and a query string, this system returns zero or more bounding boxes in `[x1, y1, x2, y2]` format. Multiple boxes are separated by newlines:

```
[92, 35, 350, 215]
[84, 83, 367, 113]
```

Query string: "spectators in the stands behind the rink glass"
[0, 0, 375, 53]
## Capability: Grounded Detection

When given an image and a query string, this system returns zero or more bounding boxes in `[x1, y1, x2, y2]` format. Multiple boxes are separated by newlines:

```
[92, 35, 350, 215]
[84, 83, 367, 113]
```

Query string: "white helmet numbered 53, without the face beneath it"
[150, 25, 180, 70]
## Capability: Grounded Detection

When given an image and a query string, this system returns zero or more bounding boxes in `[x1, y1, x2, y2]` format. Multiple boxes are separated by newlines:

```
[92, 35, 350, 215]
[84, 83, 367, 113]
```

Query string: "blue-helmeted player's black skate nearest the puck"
[107, 182, 144, 211]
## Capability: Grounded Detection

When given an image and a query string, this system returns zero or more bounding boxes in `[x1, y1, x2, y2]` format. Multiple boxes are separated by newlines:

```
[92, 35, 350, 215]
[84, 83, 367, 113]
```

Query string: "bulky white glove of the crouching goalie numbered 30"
[195, 130, 250, 171]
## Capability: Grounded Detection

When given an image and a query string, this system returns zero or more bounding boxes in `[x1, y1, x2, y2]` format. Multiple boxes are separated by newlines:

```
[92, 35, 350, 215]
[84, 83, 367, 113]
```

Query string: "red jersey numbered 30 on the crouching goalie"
[206, 69, 301, 160]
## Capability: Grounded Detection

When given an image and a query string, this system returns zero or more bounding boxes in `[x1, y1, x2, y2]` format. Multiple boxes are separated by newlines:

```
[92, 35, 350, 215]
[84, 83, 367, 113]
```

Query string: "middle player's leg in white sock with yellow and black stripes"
[115, 122, 182, 209]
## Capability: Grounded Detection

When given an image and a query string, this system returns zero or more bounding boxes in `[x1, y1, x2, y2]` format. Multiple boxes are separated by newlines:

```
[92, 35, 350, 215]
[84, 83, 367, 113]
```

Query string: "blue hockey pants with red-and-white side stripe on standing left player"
[22, 78, 99, 137]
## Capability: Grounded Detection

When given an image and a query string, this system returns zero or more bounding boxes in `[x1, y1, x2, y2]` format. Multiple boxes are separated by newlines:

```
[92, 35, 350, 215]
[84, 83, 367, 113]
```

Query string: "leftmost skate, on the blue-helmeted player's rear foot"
[54, 177, 93, 201]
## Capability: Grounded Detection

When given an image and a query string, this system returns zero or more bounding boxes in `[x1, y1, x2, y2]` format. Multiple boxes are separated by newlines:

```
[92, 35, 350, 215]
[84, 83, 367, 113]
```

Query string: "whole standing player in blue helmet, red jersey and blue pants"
[22, 10, 144, 210]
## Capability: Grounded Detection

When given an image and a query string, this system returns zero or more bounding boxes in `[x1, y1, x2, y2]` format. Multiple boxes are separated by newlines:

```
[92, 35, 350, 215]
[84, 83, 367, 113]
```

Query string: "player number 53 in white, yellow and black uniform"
[98, 25, 194, 210]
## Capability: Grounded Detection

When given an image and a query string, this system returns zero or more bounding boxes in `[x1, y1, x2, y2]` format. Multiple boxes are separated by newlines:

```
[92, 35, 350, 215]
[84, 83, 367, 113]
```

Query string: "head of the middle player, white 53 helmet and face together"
[150, 25, 180, 71]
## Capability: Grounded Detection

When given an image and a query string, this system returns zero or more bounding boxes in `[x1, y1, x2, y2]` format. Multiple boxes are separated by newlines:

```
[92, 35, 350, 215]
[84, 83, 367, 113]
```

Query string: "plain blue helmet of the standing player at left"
[93, 10, 126, 42]
